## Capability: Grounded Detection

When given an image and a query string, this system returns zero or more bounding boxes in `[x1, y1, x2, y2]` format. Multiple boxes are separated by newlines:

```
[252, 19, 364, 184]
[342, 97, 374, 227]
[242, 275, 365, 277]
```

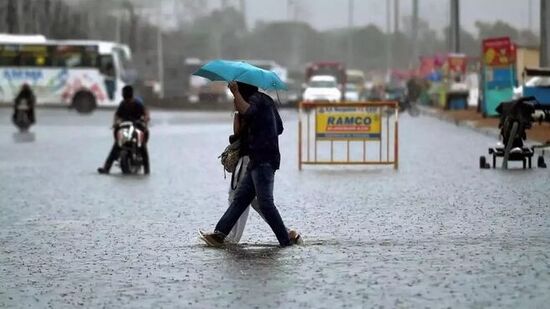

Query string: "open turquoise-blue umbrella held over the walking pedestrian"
[193, 60, 288, 90]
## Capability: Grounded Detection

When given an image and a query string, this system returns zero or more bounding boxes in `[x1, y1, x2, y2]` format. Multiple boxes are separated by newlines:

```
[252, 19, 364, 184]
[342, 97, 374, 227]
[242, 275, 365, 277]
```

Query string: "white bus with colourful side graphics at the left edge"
[0, 34, 135, 113]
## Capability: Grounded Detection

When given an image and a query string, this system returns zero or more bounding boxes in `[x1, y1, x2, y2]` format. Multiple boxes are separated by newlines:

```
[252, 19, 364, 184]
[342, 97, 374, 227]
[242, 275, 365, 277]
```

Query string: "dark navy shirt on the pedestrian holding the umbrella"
[243, 92, 283, 170]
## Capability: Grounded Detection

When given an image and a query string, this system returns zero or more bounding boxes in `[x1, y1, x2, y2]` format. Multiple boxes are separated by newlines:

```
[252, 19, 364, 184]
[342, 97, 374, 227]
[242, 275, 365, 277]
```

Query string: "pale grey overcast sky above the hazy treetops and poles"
[209, 0, 540, 32]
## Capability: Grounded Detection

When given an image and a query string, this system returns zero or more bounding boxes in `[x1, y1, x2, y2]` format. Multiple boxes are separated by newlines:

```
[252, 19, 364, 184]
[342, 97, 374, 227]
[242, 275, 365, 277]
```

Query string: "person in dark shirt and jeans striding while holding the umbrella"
[195, 61, 300, 247]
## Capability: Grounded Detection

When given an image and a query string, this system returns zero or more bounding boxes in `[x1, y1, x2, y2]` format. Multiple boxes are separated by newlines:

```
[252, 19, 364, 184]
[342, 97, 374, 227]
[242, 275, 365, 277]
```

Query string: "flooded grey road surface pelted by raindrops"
[0, 109, 550, 308]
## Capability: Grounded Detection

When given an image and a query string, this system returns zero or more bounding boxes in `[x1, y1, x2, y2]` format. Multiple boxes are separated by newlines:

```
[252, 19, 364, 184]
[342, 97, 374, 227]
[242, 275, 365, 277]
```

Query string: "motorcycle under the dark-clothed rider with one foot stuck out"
[116, 121, 145, 174]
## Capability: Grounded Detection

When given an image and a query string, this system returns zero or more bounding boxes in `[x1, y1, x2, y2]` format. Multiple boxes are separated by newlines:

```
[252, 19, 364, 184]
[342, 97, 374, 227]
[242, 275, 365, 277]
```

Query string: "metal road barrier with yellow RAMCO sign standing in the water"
[298, 101, 399, 170]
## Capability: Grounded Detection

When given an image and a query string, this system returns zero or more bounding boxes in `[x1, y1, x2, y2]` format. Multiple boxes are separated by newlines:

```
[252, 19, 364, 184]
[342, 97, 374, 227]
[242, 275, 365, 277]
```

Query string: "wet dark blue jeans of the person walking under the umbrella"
[216, 163, 290, 247]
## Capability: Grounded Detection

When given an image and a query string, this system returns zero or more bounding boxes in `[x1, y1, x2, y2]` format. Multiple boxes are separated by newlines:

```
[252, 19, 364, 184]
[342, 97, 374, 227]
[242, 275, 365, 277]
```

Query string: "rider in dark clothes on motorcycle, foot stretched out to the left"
[97, 86, 150, 174]
